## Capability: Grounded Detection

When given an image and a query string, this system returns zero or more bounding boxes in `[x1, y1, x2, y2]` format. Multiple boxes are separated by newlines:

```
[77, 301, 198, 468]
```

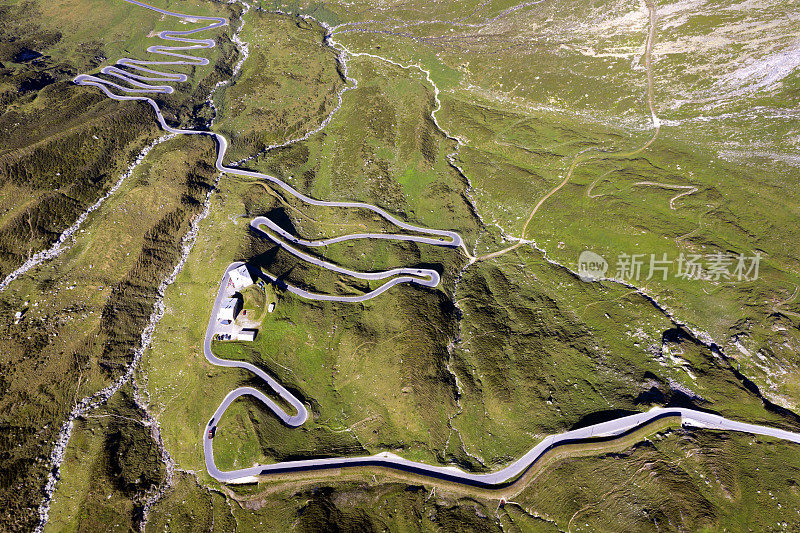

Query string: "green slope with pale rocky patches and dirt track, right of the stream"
[306, 1, 798, 409]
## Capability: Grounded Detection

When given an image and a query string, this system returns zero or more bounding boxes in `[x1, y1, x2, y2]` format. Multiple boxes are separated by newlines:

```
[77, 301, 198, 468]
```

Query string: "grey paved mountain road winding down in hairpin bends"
[75, 0, 800, 486]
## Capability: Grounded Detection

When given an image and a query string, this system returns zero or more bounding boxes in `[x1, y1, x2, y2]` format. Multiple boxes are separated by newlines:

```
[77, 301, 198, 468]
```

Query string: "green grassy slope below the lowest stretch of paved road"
[141, 429, 798, 532]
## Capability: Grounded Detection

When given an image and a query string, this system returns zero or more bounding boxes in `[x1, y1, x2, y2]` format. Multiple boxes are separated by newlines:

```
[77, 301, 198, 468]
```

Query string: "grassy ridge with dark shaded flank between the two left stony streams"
[0, 132, 214, 530]
